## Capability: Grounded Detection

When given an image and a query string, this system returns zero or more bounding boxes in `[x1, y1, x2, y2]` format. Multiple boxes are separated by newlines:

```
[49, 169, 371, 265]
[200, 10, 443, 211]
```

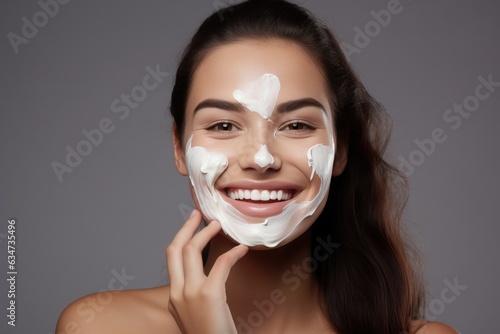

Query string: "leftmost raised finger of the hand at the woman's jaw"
[166, 209, 201, 289]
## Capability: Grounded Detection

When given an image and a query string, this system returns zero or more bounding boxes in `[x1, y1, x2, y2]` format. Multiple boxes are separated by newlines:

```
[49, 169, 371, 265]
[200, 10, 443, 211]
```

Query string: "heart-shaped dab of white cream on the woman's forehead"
[233, 73, 280, 119]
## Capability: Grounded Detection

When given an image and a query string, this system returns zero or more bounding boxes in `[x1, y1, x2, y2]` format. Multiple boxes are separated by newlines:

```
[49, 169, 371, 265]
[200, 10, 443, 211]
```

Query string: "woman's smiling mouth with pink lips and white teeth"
[219, 182, 302, 218]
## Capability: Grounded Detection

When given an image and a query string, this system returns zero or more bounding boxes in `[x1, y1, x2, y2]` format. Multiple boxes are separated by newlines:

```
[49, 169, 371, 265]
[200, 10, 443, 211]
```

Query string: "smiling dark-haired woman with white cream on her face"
[57, 0, 455, 334]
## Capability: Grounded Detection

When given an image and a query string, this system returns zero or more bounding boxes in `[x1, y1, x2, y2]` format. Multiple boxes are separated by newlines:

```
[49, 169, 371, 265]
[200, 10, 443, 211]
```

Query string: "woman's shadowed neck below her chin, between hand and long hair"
[205, 232, 323, 333]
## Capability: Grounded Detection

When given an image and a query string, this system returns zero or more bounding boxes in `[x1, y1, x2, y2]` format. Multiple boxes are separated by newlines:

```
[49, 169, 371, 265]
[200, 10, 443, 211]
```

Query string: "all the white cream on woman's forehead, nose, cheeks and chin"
[186, 74, 335, 247]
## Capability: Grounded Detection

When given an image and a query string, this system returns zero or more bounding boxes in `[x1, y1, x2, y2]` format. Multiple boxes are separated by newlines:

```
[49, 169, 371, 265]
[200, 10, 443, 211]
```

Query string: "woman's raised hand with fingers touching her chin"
[166, 210, 248, 334]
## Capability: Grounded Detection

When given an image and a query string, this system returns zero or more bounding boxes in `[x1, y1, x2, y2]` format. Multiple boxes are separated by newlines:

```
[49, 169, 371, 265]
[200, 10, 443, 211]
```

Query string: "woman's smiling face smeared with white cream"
[174, 40, 335, 247]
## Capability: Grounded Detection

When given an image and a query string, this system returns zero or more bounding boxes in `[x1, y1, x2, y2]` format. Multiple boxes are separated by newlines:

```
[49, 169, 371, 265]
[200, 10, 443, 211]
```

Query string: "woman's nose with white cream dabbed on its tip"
[239, 143, 282, 173]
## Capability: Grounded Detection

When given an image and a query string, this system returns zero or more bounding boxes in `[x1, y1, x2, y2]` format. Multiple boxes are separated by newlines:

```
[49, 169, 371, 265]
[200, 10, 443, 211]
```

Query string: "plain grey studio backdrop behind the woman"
[0, 0, 500, 333]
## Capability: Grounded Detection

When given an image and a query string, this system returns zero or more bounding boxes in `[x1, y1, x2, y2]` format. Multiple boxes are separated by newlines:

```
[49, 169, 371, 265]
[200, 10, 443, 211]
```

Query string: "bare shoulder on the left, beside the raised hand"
[56, 285, 180, 334]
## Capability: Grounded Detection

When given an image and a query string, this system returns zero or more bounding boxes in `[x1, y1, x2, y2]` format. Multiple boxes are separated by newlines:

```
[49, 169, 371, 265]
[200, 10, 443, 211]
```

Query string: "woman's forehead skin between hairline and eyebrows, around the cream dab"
[187, 40, 328, 113]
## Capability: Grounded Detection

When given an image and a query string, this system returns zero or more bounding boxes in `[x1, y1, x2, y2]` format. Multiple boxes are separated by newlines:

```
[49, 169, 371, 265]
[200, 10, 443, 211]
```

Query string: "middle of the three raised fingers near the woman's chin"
[183, 221, 221, 285]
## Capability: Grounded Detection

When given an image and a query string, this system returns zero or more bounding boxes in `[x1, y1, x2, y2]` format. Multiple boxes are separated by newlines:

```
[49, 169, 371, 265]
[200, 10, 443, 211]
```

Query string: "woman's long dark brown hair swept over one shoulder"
[170, 0, 423, 334]
